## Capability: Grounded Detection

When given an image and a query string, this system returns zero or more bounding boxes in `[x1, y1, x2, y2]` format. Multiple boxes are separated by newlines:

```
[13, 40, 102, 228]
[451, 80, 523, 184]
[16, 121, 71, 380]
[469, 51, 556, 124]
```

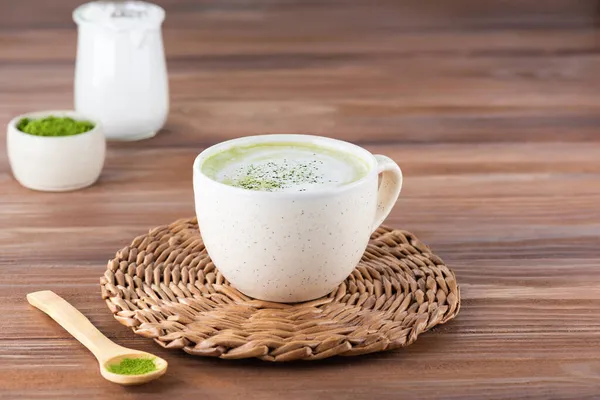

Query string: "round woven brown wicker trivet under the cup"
[100, 219, 460, 361]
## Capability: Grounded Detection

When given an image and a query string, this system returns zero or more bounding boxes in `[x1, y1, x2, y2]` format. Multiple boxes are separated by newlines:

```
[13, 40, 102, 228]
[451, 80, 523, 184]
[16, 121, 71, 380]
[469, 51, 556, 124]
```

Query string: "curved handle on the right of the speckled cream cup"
[372, 154, 402, 232]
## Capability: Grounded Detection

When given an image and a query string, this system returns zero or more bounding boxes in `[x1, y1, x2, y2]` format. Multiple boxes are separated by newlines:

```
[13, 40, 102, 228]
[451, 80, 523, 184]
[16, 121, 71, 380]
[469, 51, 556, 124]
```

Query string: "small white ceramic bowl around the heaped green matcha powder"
[6, 111, 106, 192]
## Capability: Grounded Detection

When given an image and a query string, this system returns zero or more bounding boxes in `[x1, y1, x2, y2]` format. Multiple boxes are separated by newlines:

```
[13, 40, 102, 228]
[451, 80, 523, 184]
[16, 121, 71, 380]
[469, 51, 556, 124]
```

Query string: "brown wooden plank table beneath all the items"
[0, 0, 600, 400]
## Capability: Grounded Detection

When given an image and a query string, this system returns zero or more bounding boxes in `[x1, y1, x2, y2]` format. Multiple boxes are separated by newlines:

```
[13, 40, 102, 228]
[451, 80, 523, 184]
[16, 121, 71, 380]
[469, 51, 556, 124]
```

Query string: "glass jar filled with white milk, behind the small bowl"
[73, 1, 169, 140]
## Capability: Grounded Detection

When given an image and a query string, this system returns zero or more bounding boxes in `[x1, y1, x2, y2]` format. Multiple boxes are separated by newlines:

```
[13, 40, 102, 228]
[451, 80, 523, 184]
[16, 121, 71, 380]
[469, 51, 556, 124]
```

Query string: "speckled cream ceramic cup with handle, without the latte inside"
[193, 135, 402, 302]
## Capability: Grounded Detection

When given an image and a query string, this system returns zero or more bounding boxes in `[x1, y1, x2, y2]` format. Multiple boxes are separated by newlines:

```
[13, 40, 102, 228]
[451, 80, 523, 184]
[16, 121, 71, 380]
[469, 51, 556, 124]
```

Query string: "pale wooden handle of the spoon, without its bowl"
[27, 290, 123, 363]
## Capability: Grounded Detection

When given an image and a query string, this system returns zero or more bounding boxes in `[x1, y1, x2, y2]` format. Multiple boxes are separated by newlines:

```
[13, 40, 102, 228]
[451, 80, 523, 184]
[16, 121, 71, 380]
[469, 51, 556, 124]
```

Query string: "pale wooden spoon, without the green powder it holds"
[27, 290, 167, 385]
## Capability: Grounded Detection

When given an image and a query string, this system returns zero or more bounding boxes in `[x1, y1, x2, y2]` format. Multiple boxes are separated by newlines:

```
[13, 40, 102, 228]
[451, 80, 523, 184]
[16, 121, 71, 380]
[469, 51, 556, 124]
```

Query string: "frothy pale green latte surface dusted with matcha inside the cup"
[201, 142, 369, 192]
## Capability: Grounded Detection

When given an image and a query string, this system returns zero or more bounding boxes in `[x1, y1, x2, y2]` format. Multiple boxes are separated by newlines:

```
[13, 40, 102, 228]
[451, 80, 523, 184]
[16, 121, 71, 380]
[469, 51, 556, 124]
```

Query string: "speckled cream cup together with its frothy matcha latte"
[193, 135, 402, 303]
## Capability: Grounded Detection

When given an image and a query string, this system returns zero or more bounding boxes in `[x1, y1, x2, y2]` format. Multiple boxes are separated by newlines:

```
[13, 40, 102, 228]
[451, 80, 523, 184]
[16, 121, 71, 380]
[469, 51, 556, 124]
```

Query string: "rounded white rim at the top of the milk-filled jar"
[73, 1, 165, 30]
